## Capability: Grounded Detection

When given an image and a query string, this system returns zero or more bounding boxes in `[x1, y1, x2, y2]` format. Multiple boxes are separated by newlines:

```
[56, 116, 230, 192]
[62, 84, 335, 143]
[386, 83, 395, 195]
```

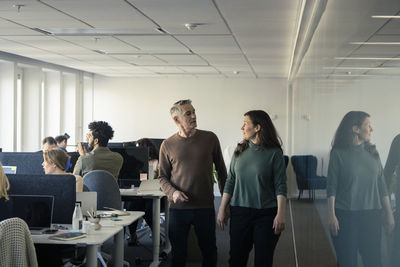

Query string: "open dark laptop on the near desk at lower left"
[0, 195, 54, 234]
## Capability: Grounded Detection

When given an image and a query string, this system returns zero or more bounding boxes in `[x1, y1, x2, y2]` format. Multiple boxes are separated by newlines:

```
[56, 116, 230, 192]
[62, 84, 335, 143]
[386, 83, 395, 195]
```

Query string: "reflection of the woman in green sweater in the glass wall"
[327, 111, 394, 267]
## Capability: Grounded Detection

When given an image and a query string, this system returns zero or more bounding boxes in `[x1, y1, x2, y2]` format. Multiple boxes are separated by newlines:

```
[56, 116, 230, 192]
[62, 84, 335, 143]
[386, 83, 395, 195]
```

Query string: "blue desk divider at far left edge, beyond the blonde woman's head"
[0, 151, 44, 175]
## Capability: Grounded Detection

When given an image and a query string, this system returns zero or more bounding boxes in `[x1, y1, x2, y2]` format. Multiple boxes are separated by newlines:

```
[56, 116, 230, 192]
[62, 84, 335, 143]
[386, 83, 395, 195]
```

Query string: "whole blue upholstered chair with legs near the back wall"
[291, 155, 326, 199]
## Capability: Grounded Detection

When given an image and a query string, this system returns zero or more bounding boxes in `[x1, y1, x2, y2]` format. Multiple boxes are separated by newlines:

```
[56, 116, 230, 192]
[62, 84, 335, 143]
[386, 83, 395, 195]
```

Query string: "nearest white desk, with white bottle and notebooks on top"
[32, 211, 144, 267]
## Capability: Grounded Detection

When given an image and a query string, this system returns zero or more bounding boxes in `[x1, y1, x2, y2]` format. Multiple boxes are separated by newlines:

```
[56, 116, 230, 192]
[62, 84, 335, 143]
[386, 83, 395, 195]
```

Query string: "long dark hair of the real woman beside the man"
[235, 110, 282, 156]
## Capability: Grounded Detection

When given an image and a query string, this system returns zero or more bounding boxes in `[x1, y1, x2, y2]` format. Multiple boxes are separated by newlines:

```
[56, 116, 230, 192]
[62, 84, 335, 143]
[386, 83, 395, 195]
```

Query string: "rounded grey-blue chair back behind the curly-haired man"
[83, 170, 122, 210]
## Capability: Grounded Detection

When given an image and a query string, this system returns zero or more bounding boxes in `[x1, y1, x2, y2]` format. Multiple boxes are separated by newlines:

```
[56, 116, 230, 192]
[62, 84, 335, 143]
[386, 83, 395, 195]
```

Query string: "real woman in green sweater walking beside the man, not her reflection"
[217, 110, 287, 267]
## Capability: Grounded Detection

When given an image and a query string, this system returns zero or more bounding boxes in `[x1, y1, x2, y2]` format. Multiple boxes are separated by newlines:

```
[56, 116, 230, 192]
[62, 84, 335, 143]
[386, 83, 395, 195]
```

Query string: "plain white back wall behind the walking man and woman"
[93, 76, 287, 155]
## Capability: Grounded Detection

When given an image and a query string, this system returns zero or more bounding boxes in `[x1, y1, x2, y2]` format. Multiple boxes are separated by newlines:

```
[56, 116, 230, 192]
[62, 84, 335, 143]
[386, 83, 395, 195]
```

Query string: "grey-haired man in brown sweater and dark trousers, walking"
[159, 100, 226, 267]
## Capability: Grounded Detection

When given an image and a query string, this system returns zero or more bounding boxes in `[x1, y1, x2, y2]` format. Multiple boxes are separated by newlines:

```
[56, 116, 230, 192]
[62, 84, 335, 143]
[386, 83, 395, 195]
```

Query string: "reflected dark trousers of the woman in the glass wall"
[332, 209, 382, 267]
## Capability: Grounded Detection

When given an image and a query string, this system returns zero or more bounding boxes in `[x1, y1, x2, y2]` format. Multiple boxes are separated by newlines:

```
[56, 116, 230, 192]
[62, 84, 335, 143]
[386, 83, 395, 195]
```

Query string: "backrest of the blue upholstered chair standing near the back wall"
[291, 155, 318, 179]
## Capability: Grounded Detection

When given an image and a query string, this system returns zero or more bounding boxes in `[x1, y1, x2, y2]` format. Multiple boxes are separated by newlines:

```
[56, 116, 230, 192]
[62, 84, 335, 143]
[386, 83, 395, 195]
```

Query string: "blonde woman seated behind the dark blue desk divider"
[42, 148, 83, 192]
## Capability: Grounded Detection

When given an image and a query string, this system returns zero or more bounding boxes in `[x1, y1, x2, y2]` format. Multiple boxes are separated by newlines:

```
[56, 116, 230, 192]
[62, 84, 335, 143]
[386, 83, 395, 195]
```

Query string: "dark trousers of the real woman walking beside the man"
[229, 206, 280, 267]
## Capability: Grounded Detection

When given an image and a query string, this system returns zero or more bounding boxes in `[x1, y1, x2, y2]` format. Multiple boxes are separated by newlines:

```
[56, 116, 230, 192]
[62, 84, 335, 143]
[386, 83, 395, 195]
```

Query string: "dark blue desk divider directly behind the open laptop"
[7, 174, 76, 224]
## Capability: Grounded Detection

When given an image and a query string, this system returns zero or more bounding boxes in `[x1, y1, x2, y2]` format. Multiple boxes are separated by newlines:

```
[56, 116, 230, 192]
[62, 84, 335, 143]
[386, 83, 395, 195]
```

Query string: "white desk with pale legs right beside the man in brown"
[120, 189, 171, 267]
